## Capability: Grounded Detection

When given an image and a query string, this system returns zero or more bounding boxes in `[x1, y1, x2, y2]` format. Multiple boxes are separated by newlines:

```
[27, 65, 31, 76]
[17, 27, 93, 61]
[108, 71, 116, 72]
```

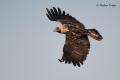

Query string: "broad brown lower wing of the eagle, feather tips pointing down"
[61, 35, 90, 67]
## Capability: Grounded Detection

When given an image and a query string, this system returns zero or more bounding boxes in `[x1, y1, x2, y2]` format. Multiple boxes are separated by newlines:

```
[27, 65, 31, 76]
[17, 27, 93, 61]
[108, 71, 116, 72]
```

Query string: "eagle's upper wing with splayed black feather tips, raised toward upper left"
[46, 7, 84, 28]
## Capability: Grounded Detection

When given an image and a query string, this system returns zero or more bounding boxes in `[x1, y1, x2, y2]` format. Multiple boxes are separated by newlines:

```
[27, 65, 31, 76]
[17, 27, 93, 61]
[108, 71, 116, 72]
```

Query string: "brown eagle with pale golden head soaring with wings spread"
[46, 7, 103, 67]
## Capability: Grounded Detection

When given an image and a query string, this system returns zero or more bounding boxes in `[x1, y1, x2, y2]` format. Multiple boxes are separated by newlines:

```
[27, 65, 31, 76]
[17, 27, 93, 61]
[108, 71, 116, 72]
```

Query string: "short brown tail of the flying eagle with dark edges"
[87, 29, 103, 41]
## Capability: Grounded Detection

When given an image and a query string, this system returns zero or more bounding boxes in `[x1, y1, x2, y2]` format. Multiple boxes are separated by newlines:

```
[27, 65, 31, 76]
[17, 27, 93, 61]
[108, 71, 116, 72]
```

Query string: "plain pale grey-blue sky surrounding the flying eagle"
[0, 0, 120, 80]
